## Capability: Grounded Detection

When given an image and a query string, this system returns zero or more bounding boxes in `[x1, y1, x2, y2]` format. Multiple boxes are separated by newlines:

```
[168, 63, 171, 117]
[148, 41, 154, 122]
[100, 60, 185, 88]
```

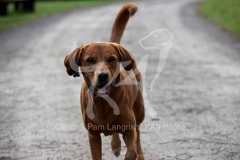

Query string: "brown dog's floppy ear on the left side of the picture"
[64, 45, 83, 76]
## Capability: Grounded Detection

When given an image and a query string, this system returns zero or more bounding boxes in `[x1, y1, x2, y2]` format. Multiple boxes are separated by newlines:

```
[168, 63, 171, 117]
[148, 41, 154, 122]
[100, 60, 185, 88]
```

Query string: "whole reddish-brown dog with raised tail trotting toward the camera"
[64, 3, 144, 160]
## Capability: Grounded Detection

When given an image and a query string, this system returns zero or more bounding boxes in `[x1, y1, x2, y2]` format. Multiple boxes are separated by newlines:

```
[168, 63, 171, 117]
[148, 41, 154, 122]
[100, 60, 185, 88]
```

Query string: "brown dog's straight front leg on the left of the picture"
[88, 132, 102, 160]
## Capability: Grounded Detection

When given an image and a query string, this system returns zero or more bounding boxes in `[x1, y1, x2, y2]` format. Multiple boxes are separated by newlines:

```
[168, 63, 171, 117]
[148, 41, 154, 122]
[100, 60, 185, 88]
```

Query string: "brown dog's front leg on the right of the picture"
[123, 130, 137, 160]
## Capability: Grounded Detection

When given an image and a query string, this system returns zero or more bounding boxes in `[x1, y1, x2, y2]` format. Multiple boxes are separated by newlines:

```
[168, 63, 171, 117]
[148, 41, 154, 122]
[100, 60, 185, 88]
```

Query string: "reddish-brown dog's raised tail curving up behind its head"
[109, 3, 138, 43]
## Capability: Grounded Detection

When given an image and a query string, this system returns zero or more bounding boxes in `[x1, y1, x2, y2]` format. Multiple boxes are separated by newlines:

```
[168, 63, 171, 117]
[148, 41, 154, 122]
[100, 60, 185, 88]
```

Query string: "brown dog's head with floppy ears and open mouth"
[64, 42, 135, 94]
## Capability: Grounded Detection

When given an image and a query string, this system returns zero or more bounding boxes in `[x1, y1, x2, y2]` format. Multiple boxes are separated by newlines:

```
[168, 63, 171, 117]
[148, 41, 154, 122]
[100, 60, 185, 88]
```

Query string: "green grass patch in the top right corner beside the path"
[200, 0, 240, 36]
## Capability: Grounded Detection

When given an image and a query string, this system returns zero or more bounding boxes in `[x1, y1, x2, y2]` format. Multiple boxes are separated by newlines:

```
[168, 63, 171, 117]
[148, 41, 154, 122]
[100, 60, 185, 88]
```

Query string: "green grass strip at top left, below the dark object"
[0, 0, 118, 32]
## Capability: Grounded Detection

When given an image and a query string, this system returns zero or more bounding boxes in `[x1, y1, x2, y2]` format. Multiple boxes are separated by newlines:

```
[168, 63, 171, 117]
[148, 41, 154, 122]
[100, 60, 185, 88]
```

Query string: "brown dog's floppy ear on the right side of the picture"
[111, 43, 136, 71]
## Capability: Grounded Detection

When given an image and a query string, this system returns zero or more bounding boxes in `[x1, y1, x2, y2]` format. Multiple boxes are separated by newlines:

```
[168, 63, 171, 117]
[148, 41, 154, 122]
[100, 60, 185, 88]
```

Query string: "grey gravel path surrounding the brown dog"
[0, 0, 240, 160]
